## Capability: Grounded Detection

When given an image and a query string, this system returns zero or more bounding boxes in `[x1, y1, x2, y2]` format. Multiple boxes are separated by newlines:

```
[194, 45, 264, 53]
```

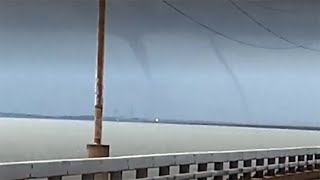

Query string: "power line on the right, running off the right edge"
[229, 0, 320, 52]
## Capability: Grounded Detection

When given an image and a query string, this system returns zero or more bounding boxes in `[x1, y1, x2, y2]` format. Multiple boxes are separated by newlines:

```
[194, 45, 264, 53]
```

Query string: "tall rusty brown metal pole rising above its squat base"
[94, 0, 106, 144]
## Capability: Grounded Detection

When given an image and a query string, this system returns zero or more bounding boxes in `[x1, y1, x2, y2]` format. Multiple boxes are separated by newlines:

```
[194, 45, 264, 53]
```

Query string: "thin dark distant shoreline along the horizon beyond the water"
[0, 112, 320, 131]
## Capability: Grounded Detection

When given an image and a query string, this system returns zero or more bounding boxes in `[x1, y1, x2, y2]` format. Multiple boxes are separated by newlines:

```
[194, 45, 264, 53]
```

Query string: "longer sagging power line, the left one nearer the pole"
[162, 0, 299, 50]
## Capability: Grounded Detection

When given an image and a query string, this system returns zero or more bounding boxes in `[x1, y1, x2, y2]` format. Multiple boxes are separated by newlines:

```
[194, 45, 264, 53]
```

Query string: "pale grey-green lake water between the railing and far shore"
[0, 118, 320, 162]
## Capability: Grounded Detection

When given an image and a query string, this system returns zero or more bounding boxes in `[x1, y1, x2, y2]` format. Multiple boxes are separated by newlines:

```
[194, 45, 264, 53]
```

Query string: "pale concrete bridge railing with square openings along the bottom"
[0, 147, 320, 180]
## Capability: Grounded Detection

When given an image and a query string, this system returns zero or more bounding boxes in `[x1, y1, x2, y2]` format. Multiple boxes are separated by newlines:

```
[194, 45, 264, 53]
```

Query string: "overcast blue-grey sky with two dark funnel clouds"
[0, 0, 320, 125]
